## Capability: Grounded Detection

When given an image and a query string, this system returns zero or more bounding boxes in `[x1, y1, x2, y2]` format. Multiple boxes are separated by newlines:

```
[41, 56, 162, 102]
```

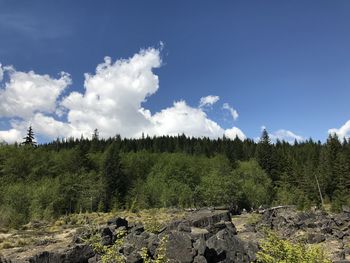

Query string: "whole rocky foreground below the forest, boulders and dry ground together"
[0, 207, 350, 263]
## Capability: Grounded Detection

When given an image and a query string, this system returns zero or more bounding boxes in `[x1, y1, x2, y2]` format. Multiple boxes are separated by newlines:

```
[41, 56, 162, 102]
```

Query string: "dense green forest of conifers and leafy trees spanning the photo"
[0, 128, 350, 227]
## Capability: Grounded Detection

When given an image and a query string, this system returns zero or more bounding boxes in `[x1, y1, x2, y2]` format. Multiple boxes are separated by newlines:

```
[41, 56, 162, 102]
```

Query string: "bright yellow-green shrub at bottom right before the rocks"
[257, 232, 332, 263]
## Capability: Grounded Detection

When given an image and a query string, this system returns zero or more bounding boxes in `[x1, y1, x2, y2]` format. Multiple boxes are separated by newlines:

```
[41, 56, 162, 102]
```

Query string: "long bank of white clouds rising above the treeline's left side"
[0, 48, 246, 143]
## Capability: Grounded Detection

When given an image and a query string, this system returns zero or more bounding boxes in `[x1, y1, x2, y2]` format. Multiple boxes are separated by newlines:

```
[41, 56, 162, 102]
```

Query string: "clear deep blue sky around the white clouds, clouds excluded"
[0, 0, 350, 144]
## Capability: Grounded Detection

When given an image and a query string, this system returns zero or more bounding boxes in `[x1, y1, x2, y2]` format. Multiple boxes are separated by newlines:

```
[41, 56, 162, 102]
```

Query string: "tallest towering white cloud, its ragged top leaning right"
[62, 48, 161, 137]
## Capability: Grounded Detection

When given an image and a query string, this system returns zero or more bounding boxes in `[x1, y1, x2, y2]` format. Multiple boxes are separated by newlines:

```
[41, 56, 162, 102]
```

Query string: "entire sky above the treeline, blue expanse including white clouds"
[0, 0, 350, 143]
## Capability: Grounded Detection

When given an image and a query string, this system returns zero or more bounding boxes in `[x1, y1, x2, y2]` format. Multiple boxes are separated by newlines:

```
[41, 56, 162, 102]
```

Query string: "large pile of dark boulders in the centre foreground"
[0, 209, 258, 263]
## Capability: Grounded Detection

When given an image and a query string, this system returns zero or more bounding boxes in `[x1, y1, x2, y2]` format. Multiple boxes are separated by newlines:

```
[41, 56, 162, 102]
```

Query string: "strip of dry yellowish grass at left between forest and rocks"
[0, 209, 185, 254]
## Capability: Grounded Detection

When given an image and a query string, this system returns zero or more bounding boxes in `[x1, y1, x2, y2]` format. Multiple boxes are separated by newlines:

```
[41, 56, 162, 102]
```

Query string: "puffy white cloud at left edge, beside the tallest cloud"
[0, 67, 71, 119]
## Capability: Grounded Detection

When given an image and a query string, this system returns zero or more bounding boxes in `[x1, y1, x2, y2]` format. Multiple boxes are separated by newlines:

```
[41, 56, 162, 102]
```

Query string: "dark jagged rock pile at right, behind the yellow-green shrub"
[255, 207, 350, 263]
